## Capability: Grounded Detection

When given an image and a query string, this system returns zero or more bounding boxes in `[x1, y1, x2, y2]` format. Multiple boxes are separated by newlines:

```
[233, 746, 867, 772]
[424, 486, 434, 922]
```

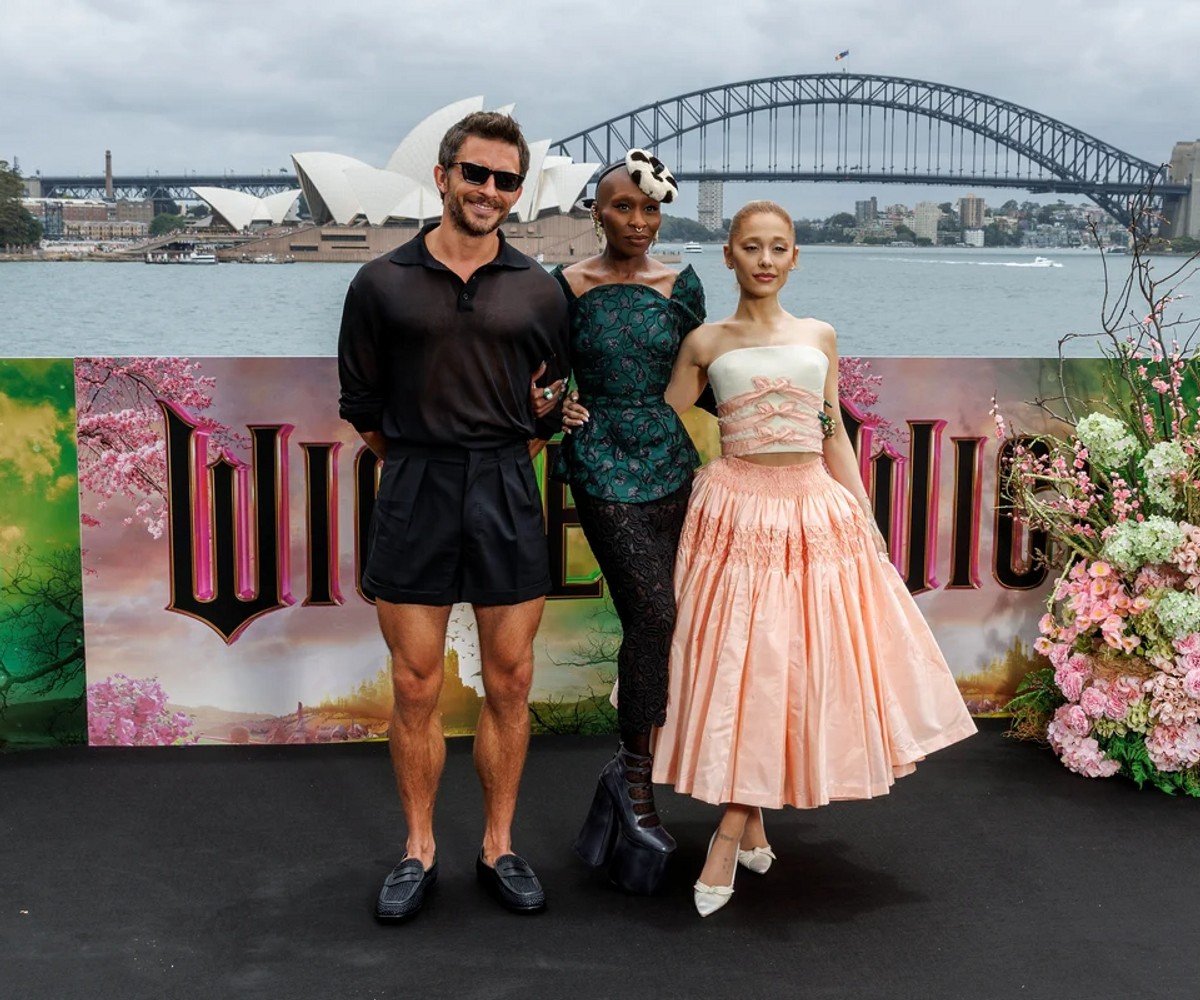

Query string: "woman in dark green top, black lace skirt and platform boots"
[554, 150, 704, 892]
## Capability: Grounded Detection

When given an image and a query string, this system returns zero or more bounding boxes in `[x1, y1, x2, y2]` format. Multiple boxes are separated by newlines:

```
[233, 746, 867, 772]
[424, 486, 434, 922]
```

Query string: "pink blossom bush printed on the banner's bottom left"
[88, 673, 196, 747]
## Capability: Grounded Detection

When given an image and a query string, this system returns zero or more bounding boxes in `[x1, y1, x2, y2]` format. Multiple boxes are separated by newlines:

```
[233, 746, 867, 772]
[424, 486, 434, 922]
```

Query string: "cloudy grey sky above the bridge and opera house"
[0, 0, 1200, 214]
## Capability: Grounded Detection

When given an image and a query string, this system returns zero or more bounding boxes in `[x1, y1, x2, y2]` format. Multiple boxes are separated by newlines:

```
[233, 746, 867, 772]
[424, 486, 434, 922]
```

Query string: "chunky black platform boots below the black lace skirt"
[575, 743, 676, 894]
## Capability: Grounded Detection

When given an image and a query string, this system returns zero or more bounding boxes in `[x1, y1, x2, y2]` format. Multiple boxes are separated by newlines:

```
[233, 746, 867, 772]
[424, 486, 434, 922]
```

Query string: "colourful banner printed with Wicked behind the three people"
[0, 358, 1089, 747]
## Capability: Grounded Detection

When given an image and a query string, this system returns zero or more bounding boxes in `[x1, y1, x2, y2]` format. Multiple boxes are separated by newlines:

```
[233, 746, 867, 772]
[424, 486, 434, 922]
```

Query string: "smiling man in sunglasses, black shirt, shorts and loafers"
[338, 112, 568, 920]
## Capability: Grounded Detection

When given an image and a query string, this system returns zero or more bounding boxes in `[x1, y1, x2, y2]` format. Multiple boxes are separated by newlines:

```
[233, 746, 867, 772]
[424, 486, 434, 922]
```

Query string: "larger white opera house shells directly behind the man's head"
[286, 97, 599, 226]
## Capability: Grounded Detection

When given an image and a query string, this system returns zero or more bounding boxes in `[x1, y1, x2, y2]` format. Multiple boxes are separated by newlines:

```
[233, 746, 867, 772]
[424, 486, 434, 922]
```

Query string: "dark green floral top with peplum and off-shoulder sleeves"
[553, 267, 704, 503]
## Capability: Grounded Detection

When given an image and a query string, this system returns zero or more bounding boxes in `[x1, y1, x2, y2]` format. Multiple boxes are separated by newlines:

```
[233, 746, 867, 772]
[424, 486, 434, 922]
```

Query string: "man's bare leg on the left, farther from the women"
[376, 600, 450, 868]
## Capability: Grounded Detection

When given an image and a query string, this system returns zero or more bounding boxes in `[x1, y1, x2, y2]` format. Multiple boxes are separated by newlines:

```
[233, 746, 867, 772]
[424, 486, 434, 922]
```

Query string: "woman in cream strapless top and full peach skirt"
[654, 202, 976, 916]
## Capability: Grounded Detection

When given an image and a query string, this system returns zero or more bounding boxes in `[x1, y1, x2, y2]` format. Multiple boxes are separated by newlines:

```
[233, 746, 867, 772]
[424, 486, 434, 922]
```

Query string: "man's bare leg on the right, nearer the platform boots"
[475, 598, 546, 864]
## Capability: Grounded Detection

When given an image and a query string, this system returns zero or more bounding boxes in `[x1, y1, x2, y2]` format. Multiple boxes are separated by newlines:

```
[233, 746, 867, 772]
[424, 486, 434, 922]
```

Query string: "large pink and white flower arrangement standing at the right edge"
[992, 347, 1200, 797]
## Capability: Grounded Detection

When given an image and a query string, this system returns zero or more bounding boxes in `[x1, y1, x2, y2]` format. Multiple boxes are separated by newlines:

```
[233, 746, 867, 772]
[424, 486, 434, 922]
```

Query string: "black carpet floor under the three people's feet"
[0, 723, 1200, 1000]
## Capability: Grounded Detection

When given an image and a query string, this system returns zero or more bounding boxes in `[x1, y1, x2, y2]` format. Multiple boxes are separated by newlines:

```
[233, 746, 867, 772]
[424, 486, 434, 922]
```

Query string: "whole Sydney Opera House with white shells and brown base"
[202, 97, 609, 262]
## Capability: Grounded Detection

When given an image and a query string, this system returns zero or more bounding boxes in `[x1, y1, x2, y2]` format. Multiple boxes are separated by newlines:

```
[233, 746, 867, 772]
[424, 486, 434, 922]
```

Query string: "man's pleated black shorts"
[362, 441, 550, 605]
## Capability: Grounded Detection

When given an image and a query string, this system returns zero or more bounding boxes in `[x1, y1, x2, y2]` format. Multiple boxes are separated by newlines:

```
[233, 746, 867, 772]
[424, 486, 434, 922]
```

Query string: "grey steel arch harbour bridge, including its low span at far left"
[41, 72, 1190, 231]
